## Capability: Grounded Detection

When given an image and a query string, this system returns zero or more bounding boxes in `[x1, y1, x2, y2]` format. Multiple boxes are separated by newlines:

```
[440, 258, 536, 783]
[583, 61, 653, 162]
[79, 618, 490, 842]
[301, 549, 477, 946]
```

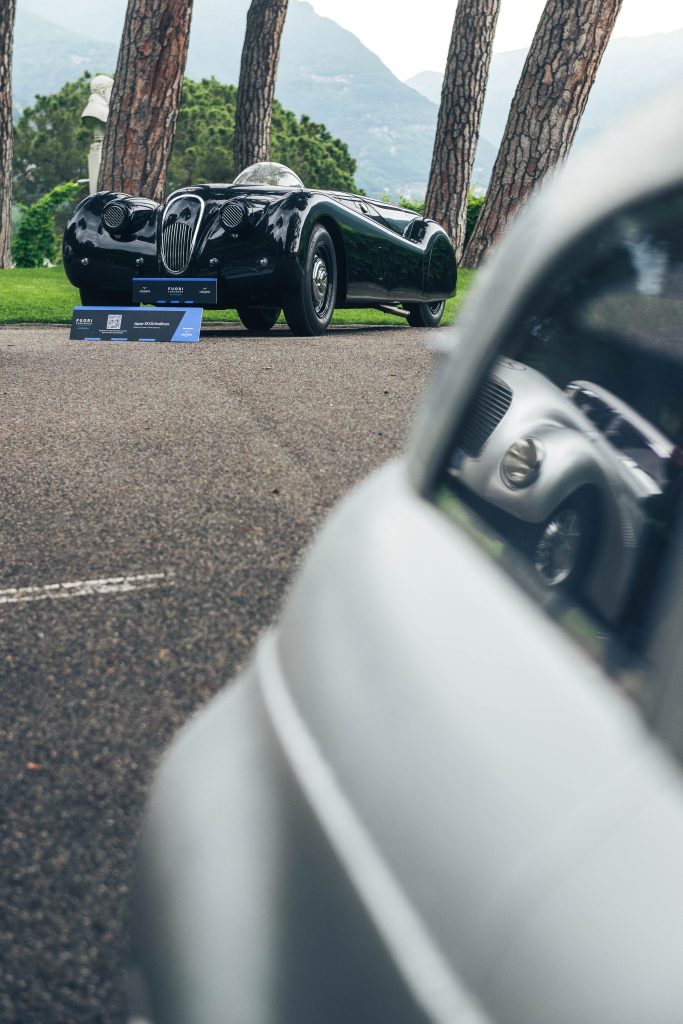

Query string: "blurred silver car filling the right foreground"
[131, 88, 683, 1024]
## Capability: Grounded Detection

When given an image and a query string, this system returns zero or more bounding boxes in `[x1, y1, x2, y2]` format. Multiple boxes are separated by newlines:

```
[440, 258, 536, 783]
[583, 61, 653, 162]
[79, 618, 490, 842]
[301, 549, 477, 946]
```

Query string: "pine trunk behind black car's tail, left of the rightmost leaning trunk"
[425, 0, 501, 261]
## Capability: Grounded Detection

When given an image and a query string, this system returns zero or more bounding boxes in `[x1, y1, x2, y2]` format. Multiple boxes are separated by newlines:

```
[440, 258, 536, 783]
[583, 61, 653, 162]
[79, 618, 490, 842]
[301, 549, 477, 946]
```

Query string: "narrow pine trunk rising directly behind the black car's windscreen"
[233, 0, 288, 174]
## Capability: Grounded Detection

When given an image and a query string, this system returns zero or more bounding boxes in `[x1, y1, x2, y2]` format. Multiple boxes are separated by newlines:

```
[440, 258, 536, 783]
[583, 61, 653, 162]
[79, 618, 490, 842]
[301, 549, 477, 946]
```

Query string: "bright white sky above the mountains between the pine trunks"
[309, 0, 683, 81]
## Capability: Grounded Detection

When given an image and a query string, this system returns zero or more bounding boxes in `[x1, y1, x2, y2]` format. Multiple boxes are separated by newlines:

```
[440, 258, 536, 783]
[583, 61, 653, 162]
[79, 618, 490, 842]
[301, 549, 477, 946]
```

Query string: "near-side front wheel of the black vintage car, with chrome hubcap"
[283, 224, 337, 335]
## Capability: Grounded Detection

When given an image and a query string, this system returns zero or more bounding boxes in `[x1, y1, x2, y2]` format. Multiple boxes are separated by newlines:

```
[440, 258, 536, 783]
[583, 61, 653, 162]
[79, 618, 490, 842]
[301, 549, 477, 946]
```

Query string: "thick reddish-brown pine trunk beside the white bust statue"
[98, 0, 193, 203]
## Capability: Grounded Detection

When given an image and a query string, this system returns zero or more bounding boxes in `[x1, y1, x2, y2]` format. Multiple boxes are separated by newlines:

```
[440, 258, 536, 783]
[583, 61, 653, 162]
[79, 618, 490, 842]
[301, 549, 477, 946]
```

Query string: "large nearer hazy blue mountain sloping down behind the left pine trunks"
[13, 0, 496, 196]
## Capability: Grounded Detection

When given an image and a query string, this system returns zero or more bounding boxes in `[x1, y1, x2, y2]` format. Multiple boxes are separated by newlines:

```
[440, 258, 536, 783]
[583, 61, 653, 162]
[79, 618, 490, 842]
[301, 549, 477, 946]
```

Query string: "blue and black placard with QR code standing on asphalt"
[71, 306, 204, 341]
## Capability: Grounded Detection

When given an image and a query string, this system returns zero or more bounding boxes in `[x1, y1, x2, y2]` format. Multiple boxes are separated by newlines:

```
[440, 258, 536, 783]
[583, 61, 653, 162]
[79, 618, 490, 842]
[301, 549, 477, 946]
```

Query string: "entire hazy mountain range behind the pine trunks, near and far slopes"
[14, 0, 683, 196]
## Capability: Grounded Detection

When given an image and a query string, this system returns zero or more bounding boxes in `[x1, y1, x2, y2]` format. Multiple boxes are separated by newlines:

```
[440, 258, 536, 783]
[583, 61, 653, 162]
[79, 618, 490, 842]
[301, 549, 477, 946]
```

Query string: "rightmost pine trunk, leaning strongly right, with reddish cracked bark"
[463, 0, 622, 267]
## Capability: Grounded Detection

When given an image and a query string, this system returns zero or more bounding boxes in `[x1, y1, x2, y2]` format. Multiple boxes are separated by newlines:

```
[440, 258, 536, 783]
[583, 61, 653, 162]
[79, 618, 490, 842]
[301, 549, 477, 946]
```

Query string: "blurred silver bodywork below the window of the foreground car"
[134, 465, 683, 1024]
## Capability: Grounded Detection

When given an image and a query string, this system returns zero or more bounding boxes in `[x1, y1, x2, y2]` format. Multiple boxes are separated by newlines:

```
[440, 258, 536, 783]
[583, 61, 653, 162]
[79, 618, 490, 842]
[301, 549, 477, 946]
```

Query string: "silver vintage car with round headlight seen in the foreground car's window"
[449, 358, 679, 623]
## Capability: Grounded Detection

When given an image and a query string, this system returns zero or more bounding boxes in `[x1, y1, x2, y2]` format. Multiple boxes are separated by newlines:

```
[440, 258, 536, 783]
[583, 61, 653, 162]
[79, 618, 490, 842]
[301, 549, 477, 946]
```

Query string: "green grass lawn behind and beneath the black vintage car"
[0, 266, 475, 325]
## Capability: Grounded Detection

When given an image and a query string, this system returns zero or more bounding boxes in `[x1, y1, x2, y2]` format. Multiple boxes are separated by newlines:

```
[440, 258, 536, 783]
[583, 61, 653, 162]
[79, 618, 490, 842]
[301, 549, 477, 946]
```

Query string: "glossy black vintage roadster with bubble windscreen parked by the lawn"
[63, 163, 457, 335]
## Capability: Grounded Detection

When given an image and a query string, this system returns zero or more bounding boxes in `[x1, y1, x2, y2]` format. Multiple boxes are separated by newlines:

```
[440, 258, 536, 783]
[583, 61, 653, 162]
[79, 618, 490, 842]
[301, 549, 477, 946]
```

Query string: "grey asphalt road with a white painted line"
[0, 327, 432, 1024]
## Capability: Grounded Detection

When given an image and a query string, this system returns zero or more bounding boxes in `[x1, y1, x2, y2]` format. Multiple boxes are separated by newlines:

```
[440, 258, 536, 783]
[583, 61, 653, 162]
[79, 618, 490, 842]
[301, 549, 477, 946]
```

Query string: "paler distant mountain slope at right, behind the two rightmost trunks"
[405, 30, 683, 156]
